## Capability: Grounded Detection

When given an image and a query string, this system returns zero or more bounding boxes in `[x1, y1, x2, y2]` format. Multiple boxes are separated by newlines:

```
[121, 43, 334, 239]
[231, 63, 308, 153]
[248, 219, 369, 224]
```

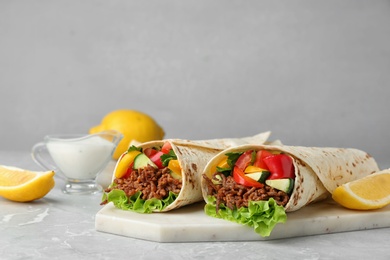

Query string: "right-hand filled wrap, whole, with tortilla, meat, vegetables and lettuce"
[201, 145, 379, 237]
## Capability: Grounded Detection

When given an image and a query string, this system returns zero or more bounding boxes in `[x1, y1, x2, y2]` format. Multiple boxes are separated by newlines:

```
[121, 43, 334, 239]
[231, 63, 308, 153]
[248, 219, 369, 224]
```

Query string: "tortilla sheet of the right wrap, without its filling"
[201, 145, 379, 212]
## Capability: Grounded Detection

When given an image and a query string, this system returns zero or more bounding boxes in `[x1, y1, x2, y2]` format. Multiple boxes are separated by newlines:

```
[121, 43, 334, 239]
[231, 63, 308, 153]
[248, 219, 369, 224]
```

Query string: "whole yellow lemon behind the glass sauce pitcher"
[89, 109, 165, 160]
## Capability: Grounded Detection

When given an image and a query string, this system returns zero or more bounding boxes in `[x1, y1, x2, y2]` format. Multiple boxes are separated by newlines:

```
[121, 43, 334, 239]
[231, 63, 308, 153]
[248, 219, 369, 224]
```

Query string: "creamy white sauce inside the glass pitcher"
[46, 136, 115, 180]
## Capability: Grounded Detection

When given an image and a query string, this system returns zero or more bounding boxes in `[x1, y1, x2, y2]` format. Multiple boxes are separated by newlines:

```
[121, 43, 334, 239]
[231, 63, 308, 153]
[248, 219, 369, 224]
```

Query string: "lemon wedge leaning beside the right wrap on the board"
[332, 169, 390, 210]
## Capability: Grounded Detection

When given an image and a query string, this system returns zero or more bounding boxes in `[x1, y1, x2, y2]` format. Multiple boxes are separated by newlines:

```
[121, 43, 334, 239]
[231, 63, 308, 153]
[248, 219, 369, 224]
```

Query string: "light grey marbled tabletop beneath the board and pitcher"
[0, 151, 390, 260]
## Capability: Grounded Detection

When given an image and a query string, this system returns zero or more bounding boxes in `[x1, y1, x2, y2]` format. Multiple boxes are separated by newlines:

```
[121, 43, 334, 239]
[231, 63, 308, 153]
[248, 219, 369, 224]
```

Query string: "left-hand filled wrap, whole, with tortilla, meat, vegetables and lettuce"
[101, 132, 270, 213]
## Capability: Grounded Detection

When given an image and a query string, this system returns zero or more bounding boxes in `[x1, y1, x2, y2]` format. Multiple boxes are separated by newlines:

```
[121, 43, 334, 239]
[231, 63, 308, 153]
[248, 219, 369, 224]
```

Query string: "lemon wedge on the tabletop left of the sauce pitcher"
[0, 165, 55, 202]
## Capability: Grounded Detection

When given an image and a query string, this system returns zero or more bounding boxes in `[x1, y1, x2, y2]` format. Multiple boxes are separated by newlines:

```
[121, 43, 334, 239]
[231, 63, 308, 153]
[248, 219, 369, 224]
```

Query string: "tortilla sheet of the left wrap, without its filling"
[102, 132, 270, 213]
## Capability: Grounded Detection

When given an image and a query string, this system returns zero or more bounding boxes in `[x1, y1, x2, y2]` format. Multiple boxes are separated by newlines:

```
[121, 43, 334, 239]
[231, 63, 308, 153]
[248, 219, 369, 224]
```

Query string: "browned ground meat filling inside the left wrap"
[102, 165, 182, 204]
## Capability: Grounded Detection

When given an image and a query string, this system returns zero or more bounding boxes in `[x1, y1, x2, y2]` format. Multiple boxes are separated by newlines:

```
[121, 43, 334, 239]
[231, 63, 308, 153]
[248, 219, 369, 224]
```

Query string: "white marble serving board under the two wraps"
[95, 200, 390, 242]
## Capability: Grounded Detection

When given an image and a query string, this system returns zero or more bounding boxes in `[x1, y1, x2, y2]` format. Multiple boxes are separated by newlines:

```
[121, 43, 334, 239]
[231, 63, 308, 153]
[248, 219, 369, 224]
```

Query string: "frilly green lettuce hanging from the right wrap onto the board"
[205, 196, 287, 237]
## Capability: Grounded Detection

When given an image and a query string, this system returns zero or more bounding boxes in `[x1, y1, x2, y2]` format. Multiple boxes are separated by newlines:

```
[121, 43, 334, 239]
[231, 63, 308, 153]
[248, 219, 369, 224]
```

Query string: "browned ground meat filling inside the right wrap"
[203, 172, 290, 212]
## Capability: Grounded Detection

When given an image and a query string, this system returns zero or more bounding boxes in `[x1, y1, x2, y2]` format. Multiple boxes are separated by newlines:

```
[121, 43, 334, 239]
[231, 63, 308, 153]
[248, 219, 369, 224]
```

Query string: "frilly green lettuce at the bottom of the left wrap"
[102, 189, 177, 213]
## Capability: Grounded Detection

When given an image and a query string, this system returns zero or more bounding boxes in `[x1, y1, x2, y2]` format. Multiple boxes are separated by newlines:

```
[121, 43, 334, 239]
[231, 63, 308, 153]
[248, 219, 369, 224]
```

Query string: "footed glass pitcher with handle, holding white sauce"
[31, 131, 123, 194]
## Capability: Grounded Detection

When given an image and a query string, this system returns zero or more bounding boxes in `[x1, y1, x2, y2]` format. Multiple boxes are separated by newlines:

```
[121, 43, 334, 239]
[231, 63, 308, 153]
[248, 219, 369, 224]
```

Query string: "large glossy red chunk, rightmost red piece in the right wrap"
[263, 154, 295, 180]
